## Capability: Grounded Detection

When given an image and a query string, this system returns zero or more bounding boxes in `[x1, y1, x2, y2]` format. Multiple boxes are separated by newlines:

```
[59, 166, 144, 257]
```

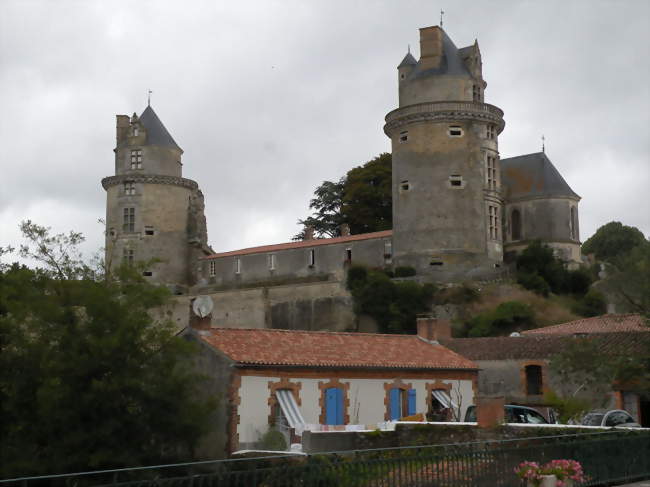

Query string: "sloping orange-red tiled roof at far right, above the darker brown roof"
[522, 313, 650, 335]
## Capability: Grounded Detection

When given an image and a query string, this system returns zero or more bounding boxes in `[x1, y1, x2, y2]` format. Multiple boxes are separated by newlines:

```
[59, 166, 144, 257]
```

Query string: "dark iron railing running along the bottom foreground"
[0, 431, 650, 487]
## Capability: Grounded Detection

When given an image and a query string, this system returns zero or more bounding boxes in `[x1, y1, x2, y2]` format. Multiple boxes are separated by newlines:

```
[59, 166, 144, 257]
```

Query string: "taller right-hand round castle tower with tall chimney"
[384, 26, 504, 281]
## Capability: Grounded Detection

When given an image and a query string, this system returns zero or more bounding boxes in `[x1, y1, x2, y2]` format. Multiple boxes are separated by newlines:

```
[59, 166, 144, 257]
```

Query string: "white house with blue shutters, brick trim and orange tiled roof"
[186, 319, 478, 456]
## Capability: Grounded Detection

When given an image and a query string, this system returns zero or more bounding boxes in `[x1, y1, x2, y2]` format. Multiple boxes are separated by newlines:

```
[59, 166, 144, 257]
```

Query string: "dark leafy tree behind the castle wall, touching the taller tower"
[294, 153, 393, 240]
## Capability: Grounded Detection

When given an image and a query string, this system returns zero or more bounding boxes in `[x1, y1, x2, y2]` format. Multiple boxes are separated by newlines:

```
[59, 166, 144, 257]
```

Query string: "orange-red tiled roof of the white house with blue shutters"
[200, 328, 478, 370]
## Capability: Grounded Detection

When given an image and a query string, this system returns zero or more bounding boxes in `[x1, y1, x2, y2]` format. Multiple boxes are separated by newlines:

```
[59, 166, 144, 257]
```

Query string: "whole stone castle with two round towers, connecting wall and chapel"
[102, 26, 581, 329]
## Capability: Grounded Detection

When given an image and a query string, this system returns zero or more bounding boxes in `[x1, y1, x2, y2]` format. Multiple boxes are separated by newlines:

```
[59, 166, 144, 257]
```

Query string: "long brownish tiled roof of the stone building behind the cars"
[443, 332, 650, 361]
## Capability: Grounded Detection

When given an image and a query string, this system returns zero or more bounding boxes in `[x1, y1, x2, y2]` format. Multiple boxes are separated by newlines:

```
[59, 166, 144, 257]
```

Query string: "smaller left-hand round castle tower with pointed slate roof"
[102, 106, 210, 292]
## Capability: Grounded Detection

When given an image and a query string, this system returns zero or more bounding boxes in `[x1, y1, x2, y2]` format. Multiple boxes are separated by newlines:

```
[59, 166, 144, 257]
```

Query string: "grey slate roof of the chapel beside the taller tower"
[501, 152, 580, 200]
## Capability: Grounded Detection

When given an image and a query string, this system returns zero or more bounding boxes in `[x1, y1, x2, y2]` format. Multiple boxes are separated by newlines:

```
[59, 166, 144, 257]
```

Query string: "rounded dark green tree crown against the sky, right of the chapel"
[582, 221, 647, 263]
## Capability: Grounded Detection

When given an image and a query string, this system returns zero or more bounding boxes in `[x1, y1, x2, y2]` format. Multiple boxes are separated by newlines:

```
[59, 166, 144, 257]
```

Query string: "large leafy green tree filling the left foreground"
[0, 223, 215, 477]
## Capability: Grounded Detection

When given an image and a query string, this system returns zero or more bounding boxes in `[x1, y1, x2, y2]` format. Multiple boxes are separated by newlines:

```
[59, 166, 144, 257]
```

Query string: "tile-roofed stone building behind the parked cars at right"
[439, 314, 650, 426]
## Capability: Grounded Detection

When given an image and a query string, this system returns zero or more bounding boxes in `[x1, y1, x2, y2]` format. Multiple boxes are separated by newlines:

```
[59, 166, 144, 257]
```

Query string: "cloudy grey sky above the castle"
[0, 0, 650, 264]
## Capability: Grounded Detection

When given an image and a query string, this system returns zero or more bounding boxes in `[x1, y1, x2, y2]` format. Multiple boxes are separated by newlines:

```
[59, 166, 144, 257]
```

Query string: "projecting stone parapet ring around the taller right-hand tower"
[384, 101, 505, 137]
